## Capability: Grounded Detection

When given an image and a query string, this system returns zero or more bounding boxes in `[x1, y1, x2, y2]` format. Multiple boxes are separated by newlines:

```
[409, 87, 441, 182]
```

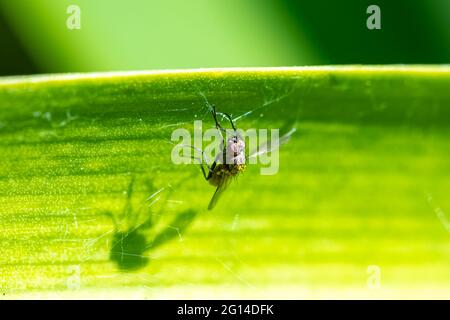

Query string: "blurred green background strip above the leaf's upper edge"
[0, 0, 450, 75]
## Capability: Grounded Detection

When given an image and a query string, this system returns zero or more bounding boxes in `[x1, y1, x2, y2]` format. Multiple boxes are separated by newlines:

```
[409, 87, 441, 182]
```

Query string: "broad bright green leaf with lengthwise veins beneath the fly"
[0, 66, 450, 298]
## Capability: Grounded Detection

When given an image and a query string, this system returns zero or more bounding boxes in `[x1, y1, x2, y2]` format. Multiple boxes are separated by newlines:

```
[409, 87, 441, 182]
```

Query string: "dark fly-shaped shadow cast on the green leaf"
[108, 179, 197, 271]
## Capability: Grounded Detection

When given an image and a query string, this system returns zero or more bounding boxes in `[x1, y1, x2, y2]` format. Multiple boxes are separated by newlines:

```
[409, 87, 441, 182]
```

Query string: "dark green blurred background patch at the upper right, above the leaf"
[281, 0, 450, 64]
